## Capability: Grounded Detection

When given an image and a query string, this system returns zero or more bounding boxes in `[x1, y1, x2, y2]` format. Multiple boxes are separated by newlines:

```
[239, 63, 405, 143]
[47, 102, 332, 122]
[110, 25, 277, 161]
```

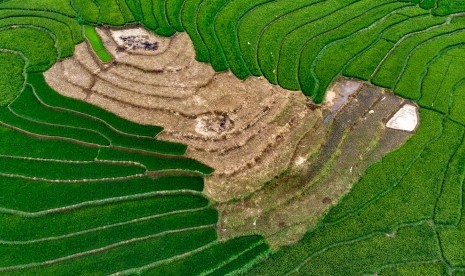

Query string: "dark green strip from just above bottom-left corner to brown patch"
[0, 209, 218, 266]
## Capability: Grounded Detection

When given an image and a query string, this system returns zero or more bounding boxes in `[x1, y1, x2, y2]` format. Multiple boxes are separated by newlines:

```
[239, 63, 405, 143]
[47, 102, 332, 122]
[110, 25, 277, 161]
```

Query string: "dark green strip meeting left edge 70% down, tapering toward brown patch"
[0, 175, 203, 212]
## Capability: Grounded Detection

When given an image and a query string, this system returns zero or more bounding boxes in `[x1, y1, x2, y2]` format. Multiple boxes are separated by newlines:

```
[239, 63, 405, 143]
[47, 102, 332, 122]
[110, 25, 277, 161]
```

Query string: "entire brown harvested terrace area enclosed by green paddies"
[45, 28, 411, 246]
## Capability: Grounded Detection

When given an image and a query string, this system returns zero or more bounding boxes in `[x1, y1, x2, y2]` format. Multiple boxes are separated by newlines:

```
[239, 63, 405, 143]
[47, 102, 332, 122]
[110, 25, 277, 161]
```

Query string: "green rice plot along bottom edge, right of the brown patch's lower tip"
[282, 225, 440, 275]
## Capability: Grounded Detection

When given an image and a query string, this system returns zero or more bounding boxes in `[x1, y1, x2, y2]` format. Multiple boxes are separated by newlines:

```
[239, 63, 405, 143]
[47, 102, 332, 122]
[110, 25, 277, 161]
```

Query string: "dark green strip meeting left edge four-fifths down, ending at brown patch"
[0, 192, 209, 241]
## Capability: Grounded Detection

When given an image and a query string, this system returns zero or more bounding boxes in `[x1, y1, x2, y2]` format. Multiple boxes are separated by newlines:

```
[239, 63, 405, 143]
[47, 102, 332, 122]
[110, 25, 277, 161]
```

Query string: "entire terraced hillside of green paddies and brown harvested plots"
[0, 0, 465, 275]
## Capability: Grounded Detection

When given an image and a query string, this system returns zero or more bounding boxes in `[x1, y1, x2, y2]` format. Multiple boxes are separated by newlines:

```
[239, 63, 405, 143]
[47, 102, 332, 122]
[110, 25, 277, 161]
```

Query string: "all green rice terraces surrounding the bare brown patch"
[0, 0, 465, 275]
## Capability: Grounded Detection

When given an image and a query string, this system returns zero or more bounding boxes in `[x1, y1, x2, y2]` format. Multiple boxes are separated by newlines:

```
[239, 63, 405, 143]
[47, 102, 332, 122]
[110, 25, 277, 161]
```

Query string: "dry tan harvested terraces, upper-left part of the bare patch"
[44, 29, 325, 201]
